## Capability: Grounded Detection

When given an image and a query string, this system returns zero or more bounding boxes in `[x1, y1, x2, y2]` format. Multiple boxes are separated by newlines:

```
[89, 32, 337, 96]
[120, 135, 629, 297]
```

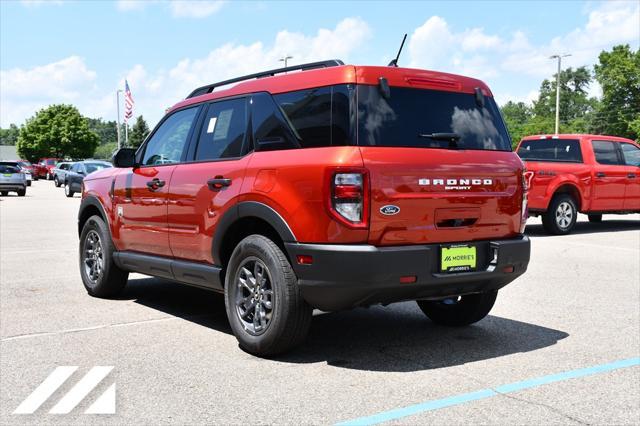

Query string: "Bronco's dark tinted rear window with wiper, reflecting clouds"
[358, 85, 511, 151]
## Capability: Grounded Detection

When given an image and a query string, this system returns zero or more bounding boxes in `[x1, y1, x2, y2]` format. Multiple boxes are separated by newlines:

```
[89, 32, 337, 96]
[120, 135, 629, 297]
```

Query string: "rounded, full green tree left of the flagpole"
[17, 105, 98, 161]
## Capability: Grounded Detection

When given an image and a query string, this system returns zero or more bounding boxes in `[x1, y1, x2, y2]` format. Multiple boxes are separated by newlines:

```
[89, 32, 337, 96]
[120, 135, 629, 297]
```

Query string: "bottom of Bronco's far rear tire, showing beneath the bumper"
[416, 291, 498, 327]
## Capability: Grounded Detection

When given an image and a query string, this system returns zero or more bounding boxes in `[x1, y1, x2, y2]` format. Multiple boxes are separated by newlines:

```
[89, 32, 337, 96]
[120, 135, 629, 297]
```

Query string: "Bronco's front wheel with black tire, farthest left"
[78, 216, 129, 298]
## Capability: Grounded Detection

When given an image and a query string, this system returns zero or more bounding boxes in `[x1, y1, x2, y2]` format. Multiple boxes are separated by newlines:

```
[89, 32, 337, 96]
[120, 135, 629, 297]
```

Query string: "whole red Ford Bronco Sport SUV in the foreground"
[78, 60, 529, 356]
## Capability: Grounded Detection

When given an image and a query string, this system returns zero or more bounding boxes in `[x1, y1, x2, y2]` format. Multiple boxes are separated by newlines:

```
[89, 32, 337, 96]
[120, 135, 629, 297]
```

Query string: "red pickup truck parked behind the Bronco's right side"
[518, 134, 640, 235]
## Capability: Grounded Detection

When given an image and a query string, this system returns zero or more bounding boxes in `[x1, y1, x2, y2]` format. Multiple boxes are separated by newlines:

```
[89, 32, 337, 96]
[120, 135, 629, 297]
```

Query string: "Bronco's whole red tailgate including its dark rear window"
[358, 86, 523, 246]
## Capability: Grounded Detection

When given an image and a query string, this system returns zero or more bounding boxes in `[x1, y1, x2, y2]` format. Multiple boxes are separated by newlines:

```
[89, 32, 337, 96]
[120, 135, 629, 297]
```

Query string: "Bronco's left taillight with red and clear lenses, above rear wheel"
[327, 169, 369, 228]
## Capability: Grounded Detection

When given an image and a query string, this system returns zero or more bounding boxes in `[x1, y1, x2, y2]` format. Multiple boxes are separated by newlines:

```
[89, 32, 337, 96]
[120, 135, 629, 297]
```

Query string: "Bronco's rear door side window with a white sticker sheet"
[196, 99, 247, 161]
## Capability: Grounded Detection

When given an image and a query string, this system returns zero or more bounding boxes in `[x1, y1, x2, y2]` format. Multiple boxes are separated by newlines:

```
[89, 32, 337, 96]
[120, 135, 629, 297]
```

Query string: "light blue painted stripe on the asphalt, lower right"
[336, 357, 640, 426]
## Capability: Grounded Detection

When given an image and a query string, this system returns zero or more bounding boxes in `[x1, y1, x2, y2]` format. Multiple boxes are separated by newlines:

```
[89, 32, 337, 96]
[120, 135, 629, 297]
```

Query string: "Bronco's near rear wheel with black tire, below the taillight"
[224, 235, 312, 356]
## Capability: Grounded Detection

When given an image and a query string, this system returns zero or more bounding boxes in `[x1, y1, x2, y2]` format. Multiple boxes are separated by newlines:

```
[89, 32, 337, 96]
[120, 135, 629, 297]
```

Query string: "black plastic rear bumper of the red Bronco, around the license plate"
[285, 236, 530, 311]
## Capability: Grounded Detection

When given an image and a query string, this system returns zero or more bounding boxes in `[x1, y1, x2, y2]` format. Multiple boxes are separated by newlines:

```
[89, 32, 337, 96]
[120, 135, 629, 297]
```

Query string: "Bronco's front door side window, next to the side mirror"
[142, 107, 198, 166]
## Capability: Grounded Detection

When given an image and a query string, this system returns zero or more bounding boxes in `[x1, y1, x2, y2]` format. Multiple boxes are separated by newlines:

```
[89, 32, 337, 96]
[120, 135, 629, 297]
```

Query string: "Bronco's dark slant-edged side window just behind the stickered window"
[251, 93, 300, 151]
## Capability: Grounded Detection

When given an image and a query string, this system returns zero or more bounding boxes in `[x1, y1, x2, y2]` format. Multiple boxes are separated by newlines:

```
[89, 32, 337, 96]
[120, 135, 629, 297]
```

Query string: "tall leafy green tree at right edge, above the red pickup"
[594, 45, 640, 139]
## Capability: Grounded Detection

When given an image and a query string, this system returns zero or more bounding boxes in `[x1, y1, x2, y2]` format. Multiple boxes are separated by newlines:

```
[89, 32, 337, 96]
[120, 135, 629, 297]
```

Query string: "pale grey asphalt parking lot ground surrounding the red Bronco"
[0, 181, 640, 425]
